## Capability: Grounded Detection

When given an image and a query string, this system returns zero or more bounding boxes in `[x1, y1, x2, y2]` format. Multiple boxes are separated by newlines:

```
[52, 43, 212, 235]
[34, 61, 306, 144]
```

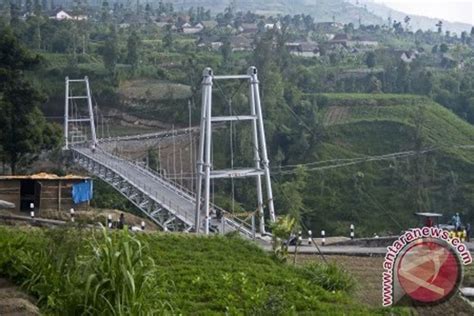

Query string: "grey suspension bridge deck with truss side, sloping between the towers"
[72, 147, 253, 237]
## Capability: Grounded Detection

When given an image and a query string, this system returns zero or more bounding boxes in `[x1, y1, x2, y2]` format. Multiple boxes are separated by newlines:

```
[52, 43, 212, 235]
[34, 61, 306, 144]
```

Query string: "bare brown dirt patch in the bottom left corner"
[0, 278, 40, 316]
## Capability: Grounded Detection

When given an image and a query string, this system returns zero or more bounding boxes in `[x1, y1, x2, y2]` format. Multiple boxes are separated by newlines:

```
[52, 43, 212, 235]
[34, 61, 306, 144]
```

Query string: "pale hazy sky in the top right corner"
[374, 0, 474, 25]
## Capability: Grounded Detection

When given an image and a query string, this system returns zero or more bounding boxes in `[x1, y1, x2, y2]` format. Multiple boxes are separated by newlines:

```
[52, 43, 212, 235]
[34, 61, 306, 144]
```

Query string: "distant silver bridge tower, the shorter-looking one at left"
[64, 76, 97, 149]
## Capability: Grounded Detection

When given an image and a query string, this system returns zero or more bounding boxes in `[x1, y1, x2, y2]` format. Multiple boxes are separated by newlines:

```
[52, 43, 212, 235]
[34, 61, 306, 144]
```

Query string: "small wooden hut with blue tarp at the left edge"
[0, 173, 93, 212]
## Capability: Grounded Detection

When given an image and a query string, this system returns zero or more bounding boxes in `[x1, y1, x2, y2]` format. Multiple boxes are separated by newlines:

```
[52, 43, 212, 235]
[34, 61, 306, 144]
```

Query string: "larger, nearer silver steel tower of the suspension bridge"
[195, 67, 275, 234]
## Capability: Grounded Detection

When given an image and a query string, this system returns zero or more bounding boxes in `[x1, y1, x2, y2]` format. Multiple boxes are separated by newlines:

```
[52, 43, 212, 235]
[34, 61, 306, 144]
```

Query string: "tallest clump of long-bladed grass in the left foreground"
[79, 229, 164, 315]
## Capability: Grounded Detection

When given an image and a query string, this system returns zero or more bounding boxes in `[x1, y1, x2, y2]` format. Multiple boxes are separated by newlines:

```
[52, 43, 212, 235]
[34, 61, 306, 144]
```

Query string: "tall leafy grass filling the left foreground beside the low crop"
[0, 228, 172, 315]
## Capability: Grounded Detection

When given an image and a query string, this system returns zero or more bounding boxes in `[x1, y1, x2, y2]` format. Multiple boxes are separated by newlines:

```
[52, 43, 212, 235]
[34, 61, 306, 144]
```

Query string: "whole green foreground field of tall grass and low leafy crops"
[0, 228, 396, 315]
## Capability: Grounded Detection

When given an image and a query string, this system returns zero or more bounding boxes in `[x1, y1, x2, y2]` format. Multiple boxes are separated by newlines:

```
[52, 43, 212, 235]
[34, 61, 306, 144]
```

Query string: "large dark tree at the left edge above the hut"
[0, 29, 60, 173]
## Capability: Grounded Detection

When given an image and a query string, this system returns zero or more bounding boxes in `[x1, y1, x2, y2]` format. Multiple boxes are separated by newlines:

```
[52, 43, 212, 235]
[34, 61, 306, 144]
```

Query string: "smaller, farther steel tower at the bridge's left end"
[64, 76, 97, 149]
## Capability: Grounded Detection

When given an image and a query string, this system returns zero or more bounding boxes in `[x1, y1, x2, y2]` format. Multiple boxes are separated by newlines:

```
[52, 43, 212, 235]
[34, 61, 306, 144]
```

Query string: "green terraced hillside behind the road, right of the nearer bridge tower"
[286, 94, 474, 236]
